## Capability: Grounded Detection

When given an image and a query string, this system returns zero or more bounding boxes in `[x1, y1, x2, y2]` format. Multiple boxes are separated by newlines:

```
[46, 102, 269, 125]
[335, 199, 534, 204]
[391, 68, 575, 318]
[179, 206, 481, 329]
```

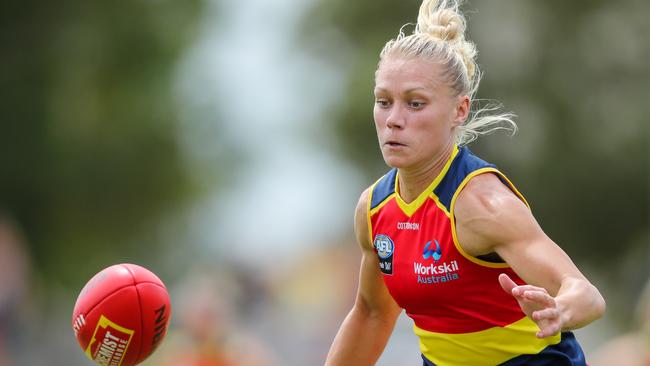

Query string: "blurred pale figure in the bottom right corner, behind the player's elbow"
[590, 279, 650, 366]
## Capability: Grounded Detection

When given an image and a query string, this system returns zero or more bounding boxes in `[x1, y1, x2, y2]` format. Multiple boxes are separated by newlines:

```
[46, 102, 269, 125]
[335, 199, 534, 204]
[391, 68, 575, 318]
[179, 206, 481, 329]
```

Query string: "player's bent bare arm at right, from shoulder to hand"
[455, 174, 605, 338]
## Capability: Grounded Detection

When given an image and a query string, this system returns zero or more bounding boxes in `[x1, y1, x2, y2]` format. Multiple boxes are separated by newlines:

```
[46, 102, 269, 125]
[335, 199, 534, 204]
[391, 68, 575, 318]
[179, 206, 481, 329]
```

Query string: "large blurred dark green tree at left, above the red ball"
[0, 0, 201, 286]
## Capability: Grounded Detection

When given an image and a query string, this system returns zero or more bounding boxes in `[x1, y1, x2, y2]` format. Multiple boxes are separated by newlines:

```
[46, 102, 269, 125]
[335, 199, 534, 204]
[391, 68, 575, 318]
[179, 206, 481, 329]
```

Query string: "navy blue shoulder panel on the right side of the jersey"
[433, 146, 496, 211]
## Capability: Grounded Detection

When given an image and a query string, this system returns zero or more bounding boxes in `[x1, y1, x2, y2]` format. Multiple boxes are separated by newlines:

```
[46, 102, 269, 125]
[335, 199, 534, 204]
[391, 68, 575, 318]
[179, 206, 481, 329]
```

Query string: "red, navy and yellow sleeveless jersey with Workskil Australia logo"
[368, 146, 584, 366]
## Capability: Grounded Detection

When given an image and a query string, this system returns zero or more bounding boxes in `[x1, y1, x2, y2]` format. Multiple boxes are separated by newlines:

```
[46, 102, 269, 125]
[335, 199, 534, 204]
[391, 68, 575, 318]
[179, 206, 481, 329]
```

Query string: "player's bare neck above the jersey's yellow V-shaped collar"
[398, 142, 454, 203]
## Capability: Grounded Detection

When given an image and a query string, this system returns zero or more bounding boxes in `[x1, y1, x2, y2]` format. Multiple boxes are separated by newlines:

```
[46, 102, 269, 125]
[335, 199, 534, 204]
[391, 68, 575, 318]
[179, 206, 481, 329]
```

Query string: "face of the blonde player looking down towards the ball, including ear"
[373, 57, 469, 169]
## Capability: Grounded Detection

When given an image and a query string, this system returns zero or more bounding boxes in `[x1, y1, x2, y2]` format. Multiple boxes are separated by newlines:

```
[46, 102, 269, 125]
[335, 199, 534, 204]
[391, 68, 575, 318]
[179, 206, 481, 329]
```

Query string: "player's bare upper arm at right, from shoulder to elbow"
[457, 174, 584, 294]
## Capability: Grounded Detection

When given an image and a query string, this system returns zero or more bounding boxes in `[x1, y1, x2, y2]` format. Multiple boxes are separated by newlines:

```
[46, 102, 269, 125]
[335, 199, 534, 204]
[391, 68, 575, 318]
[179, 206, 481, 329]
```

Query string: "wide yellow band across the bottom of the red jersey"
[413, 316, 561, 366]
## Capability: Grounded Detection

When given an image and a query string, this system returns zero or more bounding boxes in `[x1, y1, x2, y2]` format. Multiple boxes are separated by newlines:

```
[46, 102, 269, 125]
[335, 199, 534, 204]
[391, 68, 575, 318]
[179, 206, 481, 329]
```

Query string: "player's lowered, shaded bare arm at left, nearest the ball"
[325, 190, 401, 366]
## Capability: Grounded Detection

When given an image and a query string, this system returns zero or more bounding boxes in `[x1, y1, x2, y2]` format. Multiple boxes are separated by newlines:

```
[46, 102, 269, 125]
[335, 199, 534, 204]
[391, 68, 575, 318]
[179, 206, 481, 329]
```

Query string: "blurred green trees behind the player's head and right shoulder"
[300, 0, 650, 274]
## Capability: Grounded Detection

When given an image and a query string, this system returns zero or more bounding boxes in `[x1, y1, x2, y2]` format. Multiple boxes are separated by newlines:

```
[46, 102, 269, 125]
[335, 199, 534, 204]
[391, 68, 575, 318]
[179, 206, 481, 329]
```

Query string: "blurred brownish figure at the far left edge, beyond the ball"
[0, 212, 29, 366]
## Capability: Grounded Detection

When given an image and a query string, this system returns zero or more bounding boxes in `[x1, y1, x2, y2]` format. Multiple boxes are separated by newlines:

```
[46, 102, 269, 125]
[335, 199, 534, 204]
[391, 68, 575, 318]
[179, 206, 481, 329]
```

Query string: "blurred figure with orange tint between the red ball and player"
[151, 270, 277, 366]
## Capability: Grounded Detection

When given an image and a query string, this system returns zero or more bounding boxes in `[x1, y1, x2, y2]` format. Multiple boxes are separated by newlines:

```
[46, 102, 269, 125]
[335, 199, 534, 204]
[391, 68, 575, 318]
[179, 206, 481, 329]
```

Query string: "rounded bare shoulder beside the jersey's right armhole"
[454, 173, 537, 255]
